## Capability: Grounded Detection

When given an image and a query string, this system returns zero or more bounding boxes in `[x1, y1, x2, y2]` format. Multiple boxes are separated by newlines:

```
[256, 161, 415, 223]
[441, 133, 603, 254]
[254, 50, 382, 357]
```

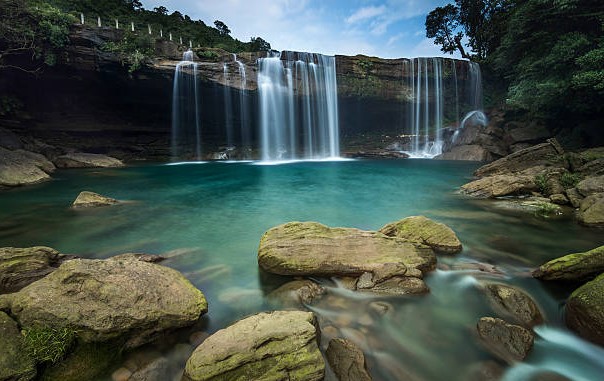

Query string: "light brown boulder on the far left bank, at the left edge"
[0, 147, 55, 187]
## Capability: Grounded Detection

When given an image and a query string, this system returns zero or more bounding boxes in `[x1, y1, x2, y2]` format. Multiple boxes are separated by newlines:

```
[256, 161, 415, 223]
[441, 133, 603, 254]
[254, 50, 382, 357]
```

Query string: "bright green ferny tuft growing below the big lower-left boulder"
[21, 327, 76, 364]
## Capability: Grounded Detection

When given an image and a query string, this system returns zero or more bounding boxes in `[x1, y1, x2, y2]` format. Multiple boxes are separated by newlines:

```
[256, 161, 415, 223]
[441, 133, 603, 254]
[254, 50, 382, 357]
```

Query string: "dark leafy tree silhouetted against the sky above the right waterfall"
[426, 4, 470, 59]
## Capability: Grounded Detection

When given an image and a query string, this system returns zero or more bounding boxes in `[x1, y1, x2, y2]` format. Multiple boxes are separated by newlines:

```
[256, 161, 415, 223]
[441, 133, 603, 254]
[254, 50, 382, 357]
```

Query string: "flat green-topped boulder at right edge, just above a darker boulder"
[533, 246, 604, 281]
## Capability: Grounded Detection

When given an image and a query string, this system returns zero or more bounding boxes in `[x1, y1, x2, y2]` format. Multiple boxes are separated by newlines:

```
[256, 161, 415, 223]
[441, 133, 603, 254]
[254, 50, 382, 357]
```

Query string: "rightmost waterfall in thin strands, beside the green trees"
[403, 57, 486, 158]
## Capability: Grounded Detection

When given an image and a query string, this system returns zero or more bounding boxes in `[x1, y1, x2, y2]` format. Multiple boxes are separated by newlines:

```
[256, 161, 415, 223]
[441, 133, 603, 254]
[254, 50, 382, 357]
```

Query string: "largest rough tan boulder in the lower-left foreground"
[5, 257, 207, 348]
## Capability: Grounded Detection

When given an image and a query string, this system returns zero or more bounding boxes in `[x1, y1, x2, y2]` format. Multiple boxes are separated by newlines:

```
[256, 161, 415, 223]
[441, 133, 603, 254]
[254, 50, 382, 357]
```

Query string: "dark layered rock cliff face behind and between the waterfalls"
[0, 26, 476, 160]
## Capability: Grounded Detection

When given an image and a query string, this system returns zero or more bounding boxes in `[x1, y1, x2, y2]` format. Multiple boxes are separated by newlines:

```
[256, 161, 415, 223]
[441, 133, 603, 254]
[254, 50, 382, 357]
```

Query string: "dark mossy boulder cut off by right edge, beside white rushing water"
[566, 274, 604, 345]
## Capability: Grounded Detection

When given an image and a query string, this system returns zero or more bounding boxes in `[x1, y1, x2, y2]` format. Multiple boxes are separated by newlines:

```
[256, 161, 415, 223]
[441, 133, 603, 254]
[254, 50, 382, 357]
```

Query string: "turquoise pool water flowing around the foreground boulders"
[0, 160, 604, 380]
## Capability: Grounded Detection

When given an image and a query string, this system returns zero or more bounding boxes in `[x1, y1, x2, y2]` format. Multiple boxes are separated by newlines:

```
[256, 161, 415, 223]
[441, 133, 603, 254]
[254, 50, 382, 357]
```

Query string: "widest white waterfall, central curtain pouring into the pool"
[258, 52, 340, 161]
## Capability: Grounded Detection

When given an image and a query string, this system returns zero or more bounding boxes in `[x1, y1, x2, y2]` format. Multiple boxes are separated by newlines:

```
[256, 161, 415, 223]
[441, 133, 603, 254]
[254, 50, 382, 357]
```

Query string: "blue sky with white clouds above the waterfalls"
[142, 0, 450, 58]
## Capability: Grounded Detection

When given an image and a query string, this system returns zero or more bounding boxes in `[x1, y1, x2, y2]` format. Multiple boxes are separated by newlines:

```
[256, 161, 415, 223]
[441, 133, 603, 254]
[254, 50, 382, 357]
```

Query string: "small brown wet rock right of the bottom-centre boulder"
[325, 339, 372, 381]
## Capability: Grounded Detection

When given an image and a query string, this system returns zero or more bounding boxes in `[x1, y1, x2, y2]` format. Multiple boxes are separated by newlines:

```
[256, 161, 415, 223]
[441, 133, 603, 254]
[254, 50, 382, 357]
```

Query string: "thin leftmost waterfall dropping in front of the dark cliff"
[172, 50, 201, 160]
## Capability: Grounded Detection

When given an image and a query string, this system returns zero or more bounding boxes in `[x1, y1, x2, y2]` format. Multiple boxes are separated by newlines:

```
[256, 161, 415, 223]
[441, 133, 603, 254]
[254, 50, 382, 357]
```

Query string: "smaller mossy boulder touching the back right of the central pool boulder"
[379, 216, 462, 254]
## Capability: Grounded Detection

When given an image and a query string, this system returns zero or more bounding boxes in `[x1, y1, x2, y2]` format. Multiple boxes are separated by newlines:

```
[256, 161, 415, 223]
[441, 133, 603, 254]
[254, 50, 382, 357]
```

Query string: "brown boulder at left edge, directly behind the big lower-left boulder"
[0, 246, 65, 294]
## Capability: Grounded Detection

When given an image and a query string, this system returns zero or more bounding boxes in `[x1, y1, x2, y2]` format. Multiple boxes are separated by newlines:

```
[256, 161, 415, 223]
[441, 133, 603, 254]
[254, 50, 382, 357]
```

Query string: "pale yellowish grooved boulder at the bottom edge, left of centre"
[183, 311, 325, 381]
